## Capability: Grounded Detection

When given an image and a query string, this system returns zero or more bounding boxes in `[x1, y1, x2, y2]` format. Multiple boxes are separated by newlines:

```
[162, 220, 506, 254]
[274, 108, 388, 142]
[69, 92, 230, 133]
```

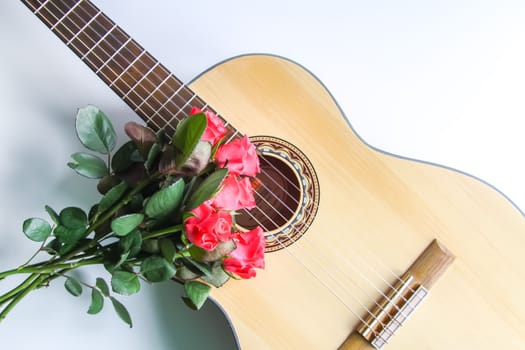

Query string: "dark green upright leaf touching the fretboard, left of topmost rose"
[173, 113, 208, 166]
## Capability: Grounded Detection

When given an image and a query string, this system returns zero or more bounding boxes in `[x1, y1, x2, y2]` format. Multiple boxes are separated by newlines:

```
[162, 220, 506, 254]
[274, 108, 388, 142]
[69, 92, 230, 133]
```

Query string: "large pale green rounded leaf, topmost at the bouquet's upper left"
[76, 106, 117, 154]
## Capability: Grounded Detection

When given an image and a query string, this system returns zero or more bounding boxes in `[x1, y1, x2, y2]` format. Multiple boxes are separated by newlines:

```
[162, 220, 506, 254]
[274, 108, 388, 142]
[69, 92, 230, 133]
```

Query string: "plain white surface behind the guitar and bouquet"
[0, 0, 525, 350]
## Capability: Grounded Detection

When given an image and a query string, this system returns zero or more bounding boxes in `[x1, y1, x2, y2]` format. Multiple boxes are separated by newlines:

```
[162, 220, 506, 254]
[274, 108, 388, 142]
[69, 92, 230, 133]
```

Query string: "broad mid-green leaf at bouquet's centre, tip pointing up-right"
[144, 179, 184, 218]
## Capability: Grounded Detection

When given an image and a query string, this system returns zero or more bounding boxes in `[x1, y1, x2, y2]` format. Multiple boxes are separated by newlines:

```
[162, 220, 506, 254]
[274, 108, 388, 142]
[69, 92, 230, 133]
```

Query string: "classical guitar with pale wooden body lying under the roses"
[19, 0, 525, 350]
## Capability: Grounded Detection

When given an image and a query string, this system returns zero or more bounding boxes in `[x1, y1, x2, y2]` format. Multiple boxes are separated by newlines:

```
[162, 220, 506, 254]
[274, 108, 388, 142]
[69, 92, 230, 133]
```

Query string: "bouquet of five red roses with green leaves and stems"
[0, 106, 265, 327]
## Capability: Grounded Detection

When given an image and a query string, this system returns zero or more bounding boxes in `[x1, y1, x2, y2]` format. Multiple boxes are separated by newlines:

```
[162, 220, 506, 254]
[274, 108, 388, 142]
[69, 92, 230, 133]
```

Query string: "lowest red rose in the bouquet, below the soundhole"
[222, 227, 265, 278]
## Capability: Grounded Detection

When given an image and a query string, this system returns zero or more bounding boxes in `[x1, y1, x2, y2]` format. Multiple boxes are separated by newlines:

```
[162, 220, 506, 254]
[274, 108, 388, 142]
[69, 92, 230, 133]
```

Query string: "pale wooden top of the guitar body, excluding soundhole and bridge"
[191, 55, 525, 349]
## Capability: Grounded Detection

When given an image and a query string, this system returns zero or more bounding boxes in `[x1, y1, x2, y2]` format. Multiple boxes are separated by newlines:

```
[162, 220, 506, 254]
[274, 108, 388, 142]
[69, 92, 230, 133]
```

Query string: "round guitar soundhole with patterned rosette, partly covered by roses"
[237, 136, 319, 252]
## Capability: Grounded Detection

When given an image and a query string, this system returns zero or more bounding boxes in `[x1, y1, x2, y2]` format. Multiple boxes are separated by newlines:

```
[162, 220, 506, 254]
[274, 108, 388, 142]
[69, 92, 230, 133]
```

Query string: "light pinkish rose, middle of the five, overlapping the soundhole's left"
[211, 175, 255, 210]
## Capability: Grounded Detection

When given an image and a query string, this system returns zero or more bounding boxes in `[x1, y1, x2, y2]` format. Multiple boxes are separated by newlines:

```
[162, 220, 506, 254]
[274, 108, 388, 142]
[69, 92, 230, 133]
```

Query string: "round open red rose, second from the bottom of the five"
[184, 203, 232, 250]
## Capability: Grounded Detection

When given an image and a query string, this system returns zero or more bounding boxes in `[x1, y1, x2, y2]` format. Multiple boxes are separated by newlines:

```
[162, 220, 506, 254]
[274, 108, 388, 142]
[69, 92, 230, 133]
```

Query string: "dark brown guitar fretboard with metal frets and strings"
[22, 0, 237, 138]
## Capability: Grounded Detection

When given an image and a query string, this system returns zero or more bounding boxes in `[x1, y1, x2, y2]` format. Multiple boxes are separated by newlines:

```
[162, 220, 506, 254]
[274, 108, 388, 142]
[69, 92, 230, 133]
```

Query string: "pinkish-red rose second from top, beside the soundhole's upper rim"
[215, 136, 260, 176]
